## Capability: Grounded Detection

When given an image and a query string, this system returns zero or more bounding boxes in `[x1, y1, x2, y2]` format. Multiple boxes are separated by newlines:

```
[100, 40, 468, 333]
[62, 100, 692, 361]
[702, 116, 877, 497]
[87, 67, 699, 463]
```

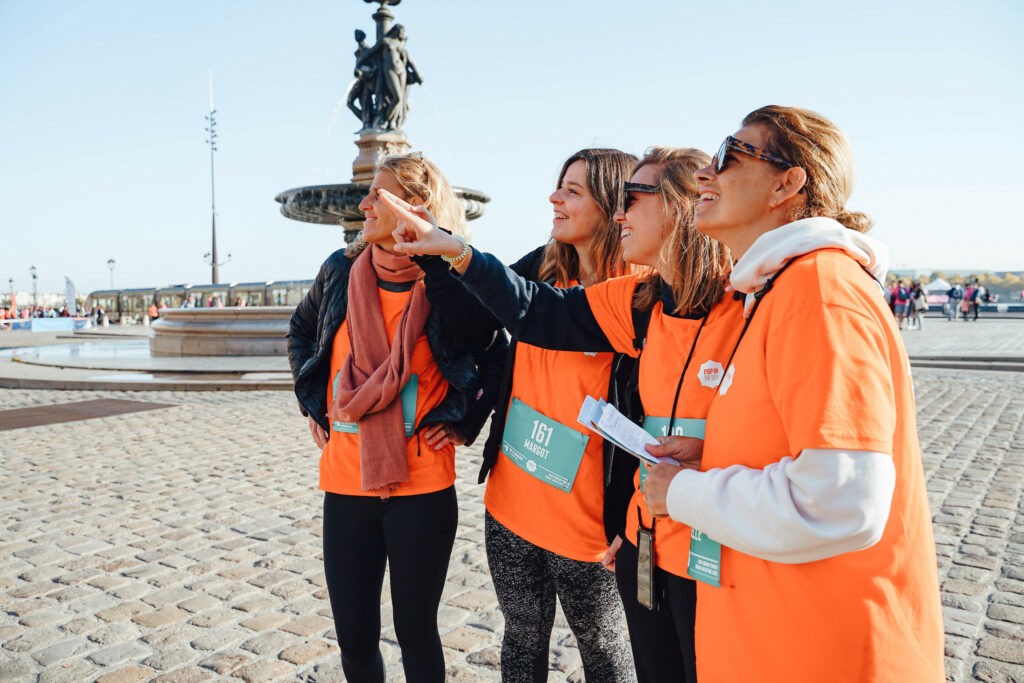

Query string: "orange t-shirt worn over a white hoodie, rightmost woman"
[696, 250, 944, 683]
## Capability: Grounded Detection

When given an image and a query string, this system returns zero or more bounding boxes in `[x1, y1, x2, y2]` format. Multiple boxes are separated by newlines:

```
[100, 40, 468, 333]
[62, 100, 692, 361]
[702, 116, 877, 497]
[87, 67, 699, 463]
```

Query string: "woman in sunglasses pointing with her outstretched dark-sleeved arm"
[385, 147, 742, 682]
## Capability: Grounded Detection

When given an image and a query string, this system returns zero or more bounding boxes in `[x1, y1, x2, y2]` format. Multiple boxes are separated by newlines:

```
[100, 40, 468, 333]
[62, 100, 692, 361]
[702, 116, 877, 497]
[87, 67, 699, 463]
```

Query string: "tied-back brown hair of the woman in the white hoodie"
[743, 104, 874, 232]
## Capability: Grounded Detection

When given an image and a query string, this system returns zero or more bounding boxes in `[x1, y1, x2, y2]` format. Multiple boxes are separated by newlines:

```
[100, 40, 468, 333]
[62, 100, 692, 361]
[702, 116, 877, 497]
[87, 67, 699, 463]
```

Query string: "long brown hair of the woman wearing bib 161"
[538, 147, 637, 286]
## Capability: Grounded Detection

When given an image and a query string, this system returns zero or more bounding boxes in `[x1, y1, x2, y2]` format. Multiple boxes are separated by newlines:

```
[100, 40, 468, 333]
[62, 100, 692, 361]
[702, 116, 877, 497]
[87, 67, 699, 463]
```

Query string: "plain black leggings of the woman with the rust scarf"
[324, 486, 459, 683]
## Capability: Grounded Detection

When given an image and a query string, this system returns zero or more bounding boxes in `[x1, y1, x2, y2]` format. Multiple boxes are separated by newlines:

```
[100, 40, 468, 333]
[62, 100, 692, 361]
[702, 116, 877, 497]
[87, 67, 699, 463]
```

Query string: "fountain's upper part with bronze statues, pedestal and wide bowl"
[274, 0, 490, 243]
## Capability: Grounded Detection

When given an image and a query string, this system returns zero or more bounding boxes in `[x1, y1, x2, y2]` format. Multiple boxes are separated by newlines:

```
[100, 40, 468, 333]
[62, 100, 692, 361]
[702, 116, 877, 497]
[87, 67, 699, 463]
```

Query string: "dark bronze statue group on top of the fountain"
[346, 0, 423, 132]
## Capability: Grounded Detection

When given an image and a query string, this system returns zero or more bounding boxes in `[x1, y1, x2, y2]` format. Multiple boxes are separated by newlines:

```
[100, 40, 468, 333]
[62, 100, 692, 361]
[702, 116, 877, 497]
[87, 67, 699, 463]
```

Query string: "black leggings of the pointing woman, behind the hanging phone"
[615, 541, 697, 683]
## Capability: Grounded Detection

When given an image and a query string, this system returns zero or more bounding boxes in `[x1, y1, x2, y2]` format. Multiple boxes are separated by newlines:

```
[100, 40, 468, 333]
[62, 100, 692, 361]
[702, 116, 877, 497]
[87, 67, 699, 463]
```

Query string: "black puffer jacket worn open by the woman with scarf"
[288, 249, 508, 443]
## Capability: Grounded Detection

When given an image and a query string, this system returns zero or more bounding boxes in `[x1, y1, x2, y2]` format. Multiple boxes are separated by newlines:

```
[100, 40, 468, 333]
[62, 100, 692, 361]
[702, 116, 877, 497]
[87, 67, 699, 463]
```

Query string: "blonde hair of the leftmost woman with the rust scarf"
[345, 152, 470, 258]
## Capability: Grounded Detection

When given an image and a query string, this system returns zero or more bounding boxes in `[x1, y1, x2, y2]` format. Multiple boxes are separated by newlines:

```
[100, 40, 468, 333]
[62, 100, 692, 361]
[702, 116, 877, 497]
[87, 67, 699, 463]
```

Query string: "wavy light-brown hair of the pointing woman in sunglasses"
[633, 146, 732, 314]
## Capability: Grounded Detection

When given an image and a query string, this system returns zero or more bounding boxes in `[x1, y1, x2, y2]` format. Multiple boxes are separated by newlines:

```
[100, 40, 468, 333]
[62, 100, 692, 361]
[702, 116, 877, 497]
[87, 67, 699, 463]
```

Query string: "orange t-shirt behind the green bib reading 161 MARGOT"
[483, 283, 612, 562]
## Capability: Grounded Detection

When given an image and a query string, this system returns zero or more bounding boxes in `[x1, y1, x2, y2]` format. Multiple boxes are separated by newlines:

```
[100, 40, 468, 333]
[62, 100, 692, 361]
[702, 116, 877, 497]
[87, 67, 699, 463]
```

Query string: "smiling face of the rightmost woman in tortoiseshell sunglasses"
[693, 125, 780, 245]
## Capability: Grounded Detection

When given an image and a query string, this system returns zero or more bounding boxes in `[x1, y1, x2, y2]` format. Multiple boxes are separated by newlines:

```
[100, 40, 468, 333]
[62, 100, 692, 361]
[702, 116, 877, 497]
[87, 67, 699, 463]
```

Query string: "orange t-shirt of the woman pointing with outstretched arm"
[587, 278, 743, 578]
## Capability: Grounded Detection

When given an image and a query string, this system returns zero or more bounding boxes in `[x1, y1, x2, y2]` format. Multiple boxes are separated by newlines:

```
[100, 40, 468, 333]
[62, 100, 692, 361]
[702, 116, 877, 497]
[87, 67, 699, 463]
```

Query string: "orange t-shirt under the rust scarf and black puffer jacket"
[319, 289, 455, 496]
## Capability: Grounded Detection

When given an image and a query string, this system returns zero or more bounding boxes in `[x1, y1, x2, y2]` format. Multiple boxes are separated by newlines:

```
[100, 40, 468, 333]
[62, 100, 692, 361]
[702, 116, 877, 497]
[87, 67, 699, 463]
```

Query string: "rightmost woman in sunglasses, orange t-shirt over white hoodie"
[647, 106, 944, 681]
